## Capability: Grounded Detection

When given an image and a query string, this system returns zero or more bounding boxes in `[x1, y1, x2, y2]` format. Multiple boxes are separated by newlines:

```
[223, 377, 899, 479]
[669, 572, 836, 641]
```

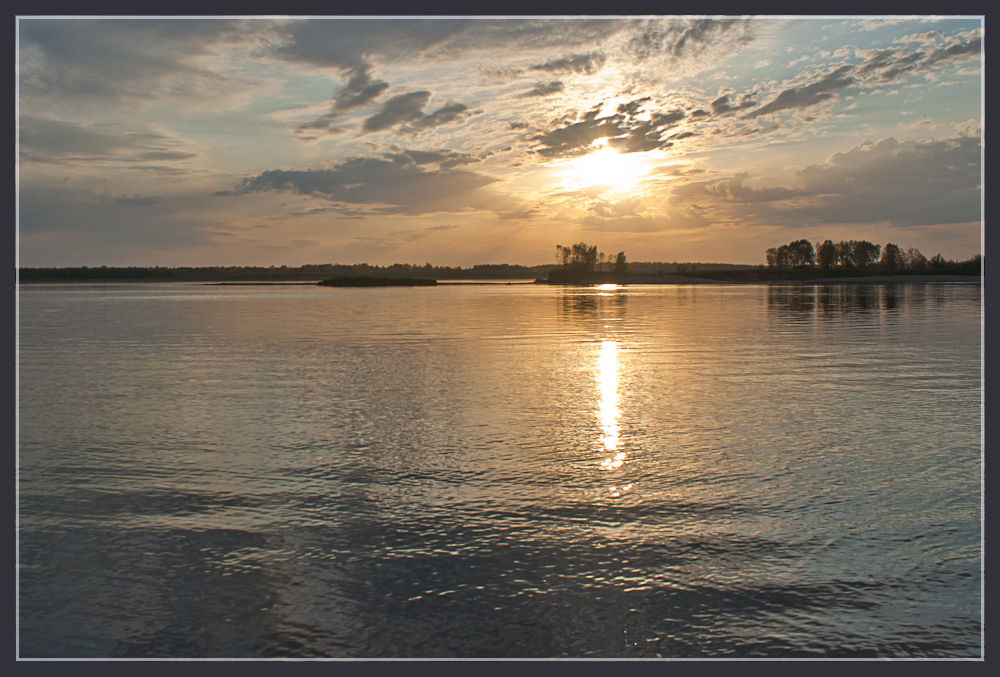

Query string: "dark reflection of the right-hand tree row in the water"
[767, 284, 912, 317]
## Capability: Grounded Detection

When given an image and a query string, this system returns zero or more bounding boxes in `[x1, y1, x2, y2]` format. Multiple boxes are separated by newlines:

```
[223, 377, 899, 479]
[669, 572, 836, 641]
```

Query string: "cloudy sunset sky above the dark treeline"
[17, 16, 983, 266]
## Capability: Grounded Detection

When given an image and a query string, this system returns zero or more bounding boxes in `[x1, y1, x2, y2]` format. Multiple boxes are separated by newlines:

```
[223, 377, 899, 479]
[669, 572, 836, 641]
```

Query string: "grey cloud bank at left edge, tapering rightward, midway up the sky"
[18, 115, 197, 163]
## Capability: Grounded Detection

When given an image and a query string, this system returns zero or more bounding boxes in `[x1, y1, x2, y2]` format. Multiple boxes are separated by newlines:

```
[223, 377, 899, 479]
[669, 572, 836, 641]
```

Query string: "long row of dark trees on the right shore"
[764, 240, 982, 271]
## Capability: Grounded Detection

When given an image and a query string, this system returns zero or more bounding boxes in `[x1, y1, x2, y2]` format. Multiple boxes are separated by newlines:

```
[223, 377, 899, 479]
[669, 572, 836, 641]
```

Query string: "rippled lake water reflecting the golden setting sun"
[18, 284, 982, 658]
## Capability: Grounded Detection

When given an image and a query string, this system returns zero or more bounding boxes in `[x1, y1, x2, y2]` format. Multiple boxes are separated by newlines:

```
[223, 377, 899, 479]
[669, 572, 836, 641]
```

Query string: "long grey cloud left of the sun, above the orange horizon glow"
[232, 151, 517, 214]
